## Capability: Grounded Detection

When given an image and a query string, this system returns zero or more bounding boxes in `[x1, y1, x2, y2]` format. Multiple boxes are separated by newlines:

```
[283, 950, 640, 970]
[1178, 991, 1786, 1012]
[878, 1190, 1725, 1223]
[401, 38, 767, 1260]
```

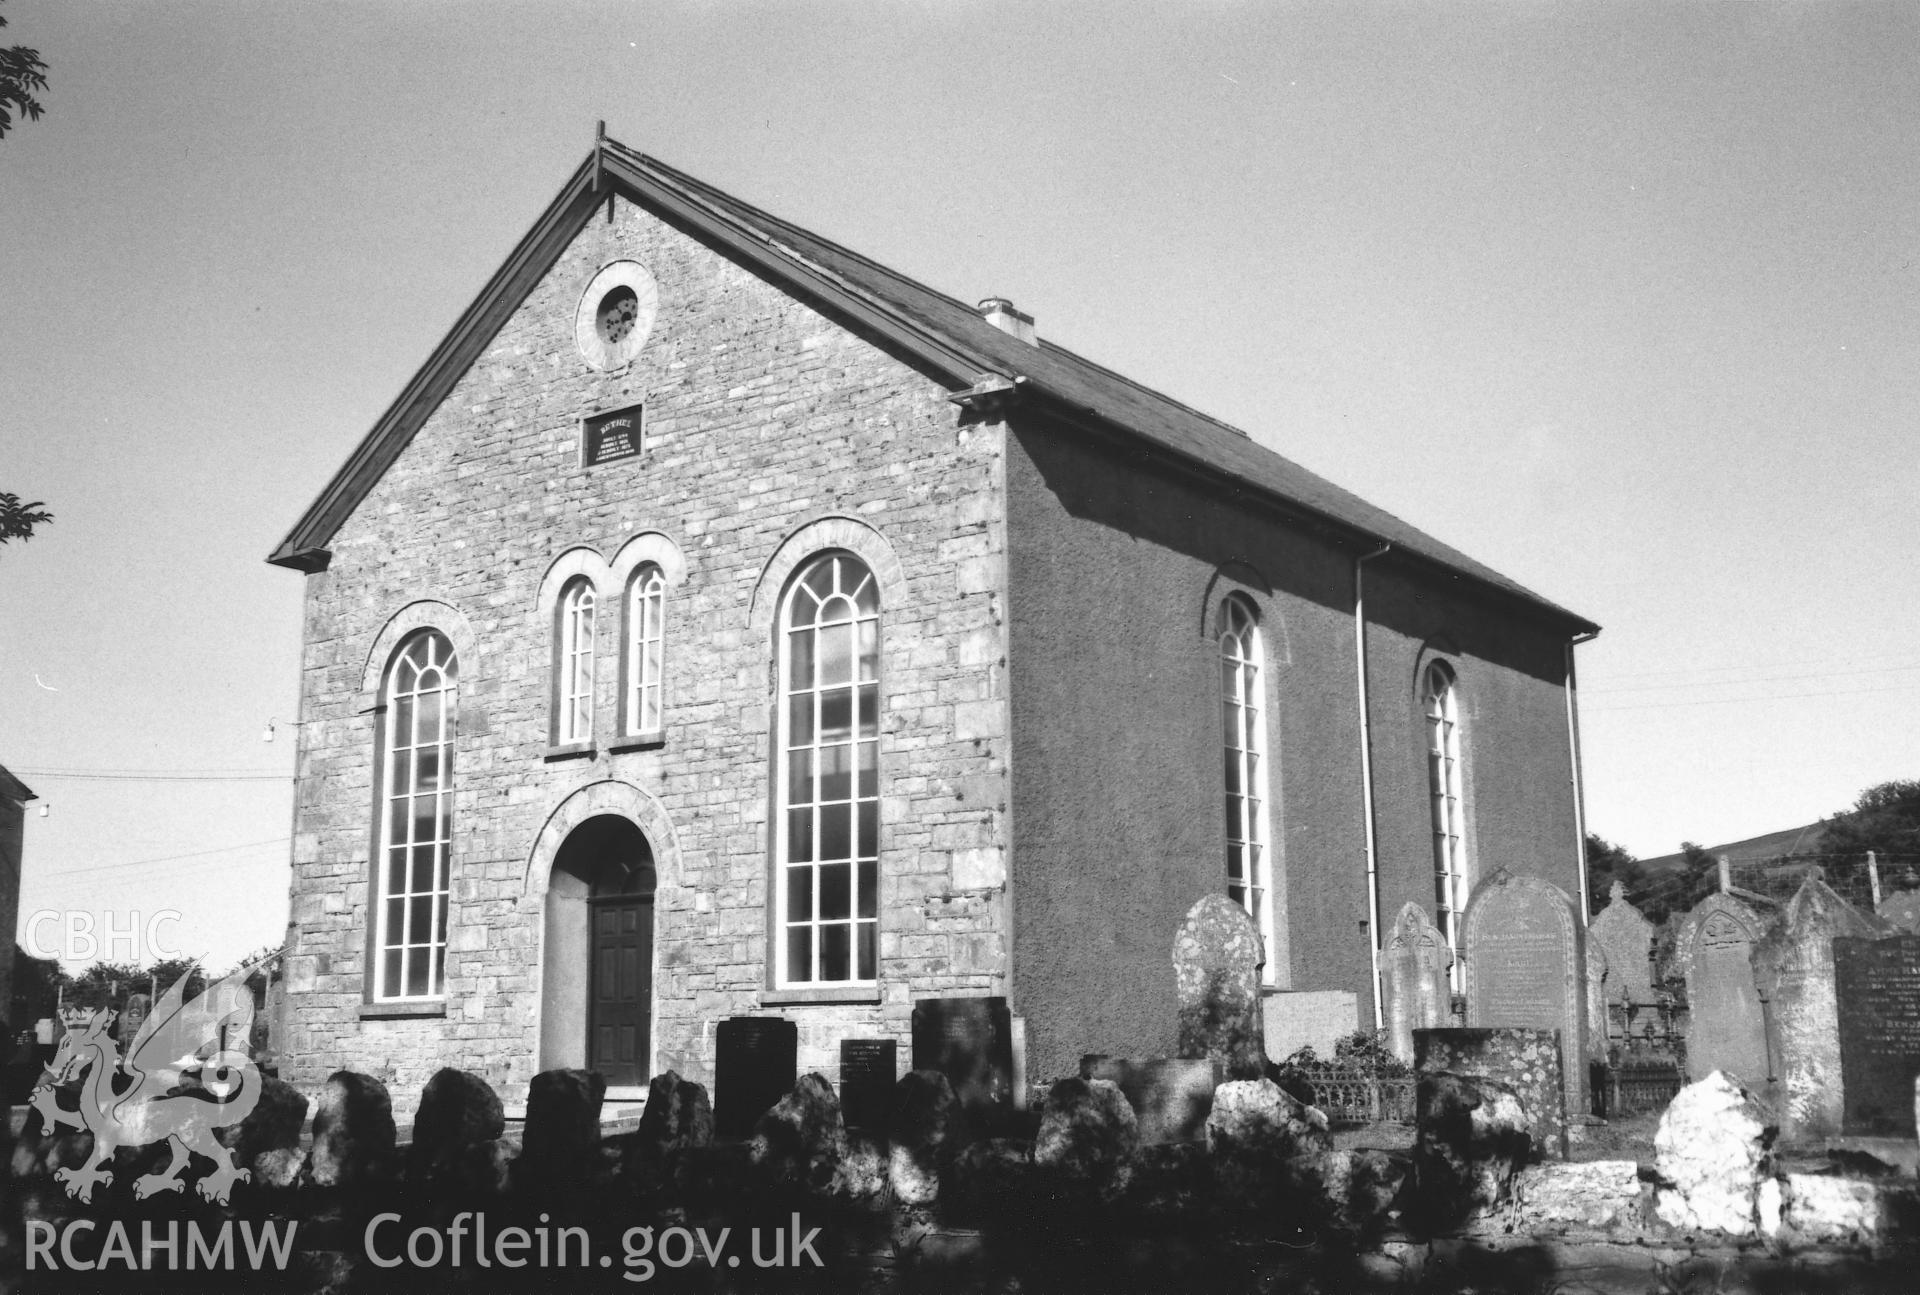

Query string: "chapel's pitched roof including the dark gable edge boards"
[269, 140, 1599, 632]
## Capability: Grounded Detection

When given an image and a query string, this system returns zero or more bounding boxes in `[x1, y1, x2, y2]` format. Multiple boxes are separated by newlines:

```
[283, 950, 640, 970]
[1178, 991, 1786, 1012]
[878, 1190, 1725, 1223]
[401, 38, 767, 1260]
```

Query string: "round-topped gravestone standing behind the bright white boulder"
[1680, 893, 1772, 1095]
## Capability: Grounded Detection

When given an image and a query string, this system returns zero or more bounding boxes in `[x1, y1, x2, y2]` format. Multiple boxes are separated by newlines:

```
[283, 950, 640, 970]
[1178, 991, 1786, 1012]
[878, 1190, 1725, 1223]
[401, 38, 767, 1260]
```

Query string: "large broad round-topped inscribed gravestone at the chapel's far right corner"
[1461, 868, 1588, 1111]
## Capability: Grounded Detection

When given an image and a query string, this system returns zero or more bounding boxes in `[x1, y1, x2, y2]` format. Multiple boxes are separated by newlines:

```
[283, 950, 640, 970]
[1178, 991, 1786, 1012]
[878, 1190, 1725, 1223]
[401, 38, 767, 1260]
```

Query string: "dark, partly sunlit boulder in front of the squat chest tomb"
[1413, 1070, 1532, 1230]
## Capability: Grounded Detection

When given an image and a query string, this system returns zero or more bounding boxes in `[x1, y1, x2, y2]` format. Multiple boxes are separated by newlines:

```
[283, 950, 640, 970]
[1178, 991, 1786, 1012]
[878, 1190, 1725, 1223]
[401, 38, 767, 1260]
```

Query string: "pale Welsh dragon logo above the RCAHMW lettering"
[33, 966, 261, 1205]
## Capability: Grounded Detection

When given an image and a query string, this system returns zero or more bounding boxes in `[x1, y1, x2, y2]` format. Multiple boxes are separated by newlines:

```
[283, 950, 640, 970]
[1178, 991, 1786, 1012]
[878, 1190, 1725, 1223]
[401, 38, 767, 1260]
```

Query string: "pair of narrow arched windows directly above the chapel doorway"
[553, 563, 666, 745]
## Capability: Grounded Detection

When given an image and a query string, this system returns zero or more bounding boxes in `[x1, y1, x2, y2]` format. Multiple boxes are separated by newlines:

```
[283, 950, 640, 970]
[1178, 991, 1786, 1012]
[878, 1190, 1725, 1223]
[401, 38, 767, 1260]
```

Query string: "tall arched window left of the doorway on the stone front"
[374, 630, 459, 999]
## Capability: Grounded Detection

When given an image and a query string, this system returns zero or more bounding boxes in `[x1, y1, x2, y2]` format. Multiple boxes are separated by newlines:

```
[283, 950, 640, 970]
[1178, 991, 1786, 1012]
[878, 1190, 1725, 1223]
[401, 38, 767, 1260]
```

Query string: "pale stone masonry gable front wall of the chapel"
[286, 200, 1008, 1107]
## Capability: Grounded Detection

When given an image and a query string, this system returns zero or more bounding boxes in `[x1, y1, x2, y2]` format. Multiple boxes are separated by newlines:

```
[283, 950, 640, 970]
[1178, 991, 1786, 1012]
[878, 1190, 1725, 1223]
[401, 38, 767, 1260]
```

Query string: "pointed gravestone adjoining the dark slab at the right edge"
[1753, 868, 1885, 1141]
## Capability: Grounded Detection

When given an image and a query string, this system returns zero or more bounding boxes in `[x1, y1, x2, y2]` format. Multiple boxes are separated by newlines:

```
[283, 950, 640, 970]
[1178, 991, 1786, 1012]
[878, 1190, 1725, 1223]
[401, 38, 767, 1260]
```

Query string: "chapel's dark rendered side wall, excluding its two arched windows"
[1008, 419, 1576, 1080]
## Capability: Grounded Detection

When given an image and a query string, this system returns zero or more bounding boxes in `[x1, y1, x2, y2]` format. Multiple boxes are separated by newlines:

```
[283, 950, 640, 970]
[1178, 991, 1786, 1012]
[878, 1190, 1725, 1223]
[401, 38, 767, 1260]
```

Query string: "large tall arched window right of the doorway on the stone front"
[774, 553, 879, 986]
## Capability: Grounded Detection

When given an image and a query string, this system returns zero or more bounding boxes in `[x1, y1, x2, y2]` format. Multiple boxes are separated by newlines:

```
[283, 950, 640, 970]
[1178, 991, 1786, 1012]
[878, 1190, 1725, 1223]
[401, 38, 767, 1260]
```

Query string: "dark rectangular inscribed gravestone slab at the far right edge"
[1834, 934, 1920, 1139]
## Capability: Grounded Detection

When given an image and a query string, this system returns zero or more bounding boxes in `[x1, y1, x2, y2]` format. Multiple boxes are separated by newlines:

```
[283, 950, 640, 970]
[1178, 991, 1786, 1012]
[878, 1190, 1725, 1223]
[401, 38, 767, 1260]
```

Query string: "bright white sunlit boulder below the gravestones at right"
[1653, 1070, 1776, 1237]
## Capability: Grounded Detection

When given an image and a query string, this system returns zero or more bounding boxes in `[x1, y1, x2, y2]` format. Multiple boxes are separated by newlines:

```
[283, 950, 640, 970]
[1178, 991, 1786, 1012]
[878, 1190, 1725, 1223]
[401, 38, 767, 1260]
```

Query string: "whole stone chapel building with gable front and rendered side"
[271, 140, 1597, 1103]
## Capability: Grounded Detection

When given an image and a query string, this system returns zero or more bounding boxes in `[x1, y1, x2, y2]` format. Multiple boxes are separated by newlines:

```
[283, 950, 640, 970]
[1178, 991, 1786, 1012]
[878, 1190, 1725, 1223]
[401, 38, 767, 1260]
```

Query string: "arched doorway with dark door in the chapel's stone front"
[540, 815, 657, 1087]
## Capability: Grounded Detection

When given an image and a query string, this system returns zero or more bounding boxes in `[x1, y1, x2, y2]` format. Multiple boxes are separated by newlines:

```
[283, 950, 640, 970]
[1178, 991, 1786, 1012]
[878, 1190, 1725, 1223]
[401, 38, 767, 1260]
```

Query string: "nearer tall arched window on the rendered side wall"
[1219, 598, 1279, 980]
